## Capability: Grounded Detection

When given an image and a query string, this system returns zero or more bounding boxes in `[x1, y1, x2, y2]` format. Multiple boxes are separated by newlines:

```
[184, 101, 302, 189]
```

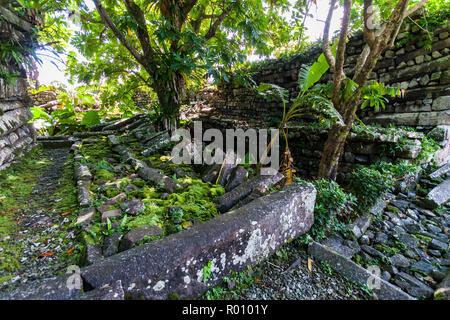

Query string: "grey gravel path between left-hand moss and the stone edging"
[0, 149, 76, 292]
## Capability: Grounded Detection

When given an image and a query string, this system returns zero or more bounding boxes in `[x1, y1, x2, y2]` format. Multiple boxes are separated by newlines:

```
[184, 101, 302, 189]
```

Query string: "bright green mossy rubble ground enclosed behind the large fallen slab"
[76, 136, 229, 249]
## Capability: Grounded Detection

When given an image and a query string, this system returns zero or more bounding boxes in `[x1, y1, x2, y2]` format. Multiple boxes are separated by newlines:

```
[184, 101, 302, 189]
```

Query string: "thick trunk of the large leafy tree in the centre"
[154, 73, 186, 132]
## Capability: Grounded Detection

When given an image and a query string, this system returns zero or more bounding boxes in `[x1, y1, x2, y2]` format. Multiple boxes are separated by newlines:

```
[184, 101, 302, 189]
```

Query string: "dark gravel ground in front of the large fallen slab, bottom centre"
[202, 243, 372, 300]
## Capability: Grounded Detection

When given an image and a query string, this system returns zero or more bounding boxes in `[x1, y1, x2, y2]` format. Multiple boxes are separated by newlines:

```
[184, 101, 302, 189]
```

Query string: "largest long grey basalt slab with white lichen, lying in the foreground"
[81, 183, 316, 299]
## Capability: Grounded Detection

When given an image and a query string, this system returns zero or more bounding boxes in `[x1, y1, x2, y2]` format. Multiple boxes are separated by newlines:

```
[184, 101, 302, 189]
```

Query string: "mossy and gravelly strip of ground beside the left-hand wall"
[0, 148, 82, 292]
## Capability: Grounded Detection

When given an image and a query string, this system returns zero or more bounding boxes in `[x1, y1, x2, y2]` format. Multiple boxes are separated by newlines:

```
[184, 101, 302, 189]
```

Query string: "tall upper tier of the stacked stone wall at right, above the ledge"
[197, 26, 450, 130]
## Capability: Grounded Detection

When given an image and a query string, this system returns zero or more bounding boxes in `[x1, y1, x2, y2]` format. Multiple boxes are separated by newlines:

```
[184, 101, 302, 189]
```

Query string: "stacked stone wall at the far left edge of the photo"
[0, 7, 35, 170]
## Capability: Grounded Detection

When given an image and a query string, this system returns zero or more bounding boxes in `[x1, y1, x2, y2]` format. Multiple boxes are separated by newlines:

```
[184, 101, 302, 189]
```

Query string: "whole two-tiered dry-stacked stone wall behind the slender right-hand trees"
[197, 21, 450, 176]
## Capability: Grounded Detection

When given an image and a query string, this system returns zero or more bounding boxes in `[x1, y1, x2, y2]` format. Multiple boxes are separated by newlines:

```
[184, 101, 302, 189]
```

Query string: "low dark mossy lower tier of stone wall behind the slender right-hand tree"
[200, 117, 432, 181]
